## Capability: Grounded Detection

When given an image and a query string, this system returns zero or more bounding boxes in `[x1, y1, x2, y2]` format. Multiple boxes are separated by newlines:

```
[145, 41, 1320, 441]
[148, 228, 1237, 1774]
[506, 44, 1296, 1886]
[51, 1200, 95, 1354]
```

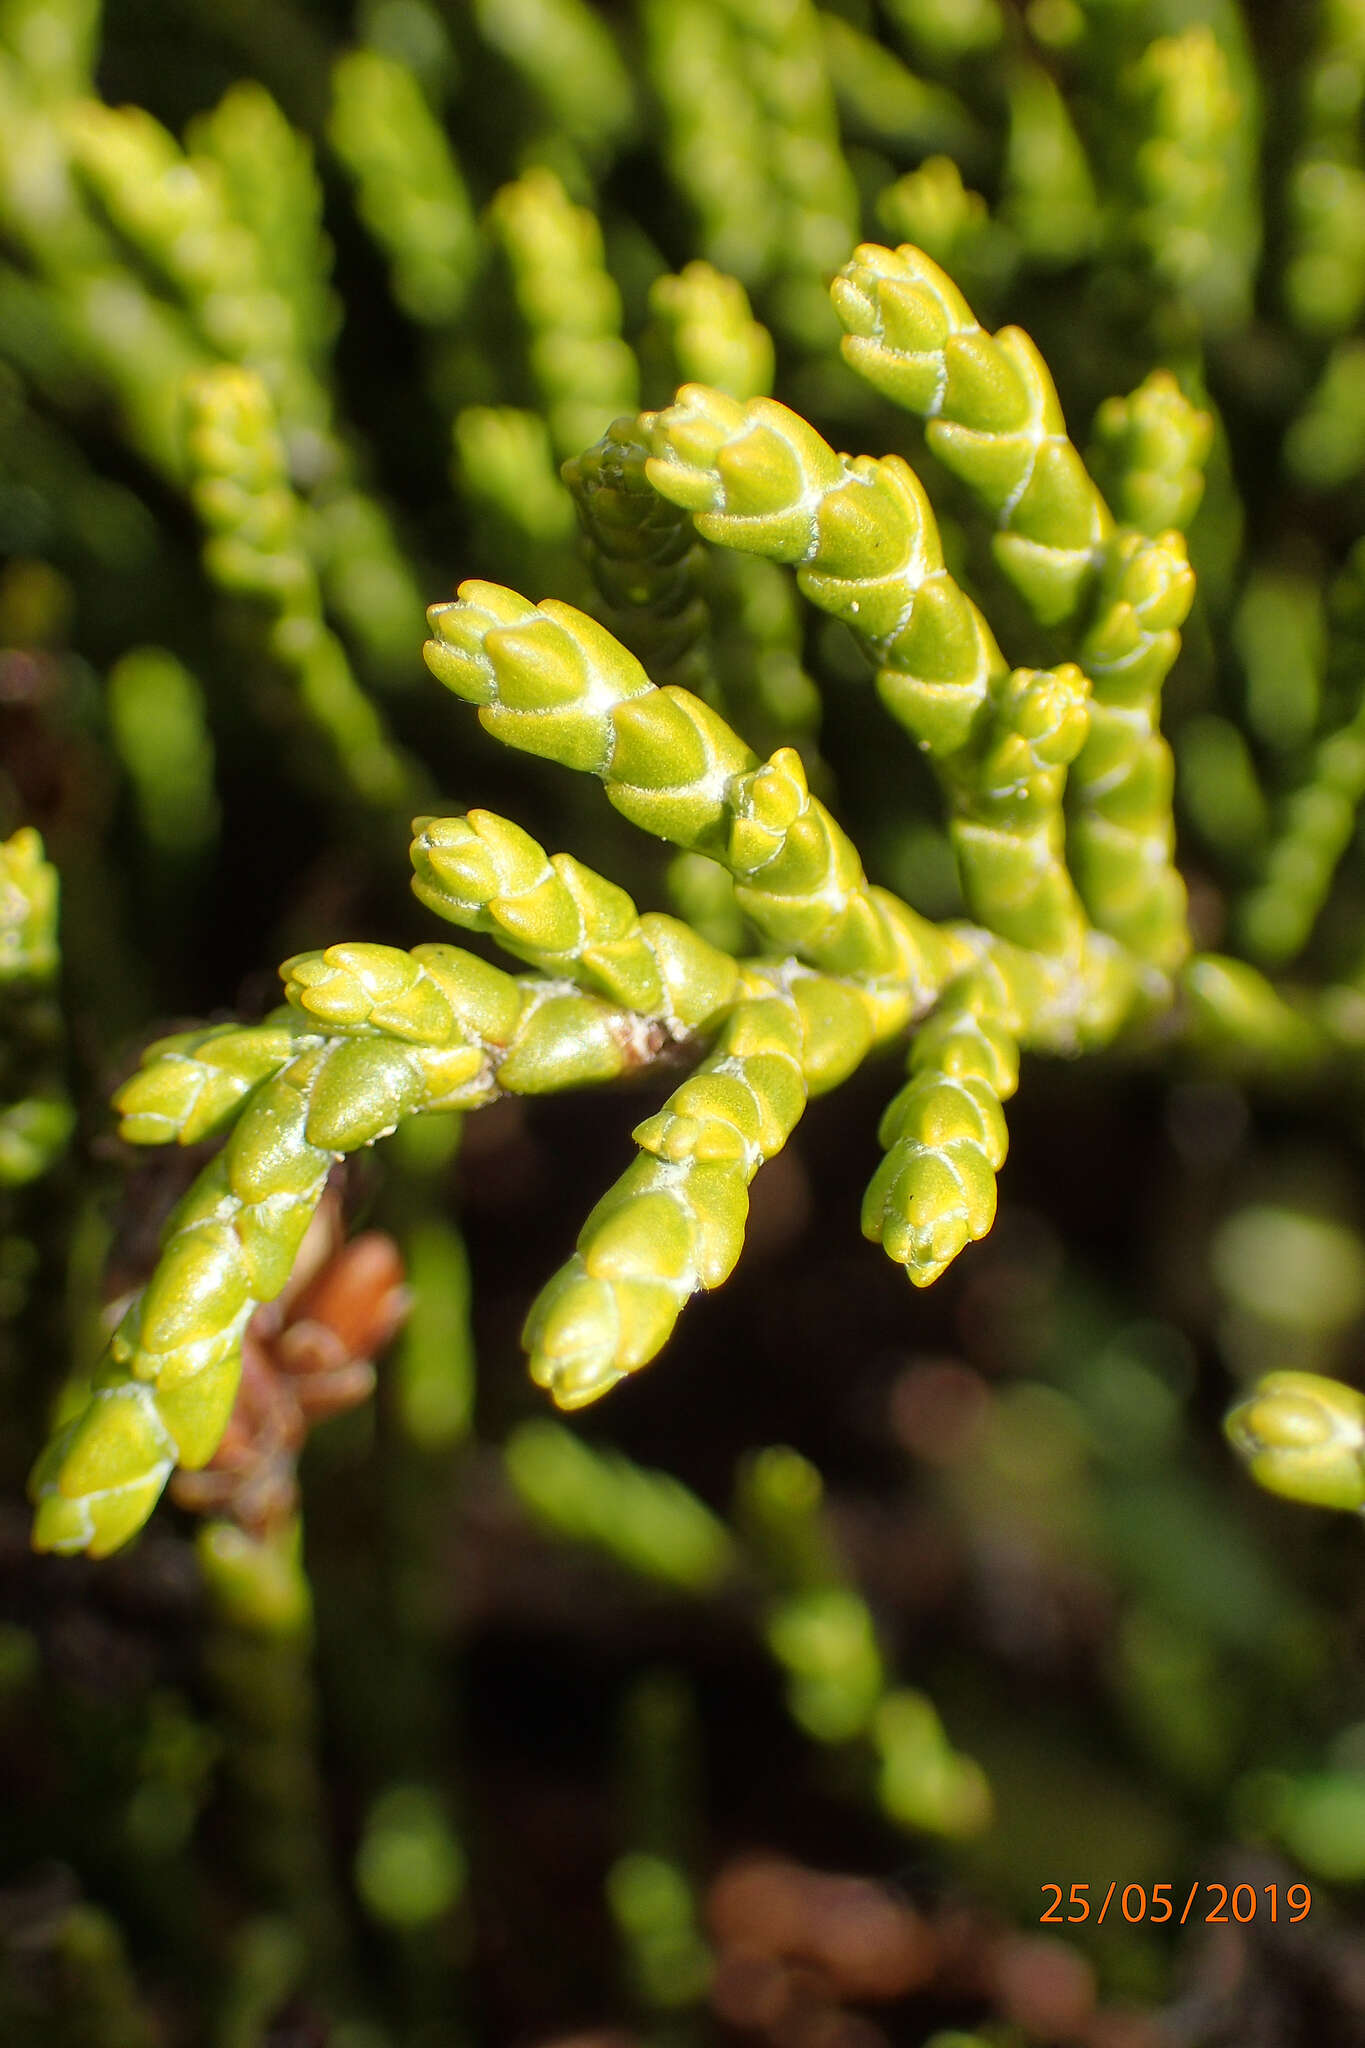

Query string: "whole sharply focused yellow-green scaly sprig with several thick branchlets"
[37, 235, 1222, 1550]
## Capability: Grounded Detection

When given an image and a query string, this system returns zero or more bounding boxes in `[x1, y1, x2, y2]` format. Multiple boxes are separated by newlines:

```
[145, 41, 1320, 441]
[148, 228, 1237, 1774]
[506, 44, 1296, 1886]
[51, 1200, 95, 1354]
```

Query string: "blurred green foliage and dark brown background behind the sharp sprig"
[0, 0, 1365, 2048]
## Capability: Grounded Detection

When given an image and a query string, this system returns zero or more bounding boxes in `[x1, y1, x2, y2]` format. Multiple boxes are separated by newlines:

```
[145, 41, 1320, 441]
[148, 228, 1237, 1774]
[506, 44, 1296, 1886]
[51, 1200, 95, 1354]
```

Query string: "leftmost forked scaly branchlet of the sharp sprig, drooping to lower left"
[33, 944, 687, 1554]
